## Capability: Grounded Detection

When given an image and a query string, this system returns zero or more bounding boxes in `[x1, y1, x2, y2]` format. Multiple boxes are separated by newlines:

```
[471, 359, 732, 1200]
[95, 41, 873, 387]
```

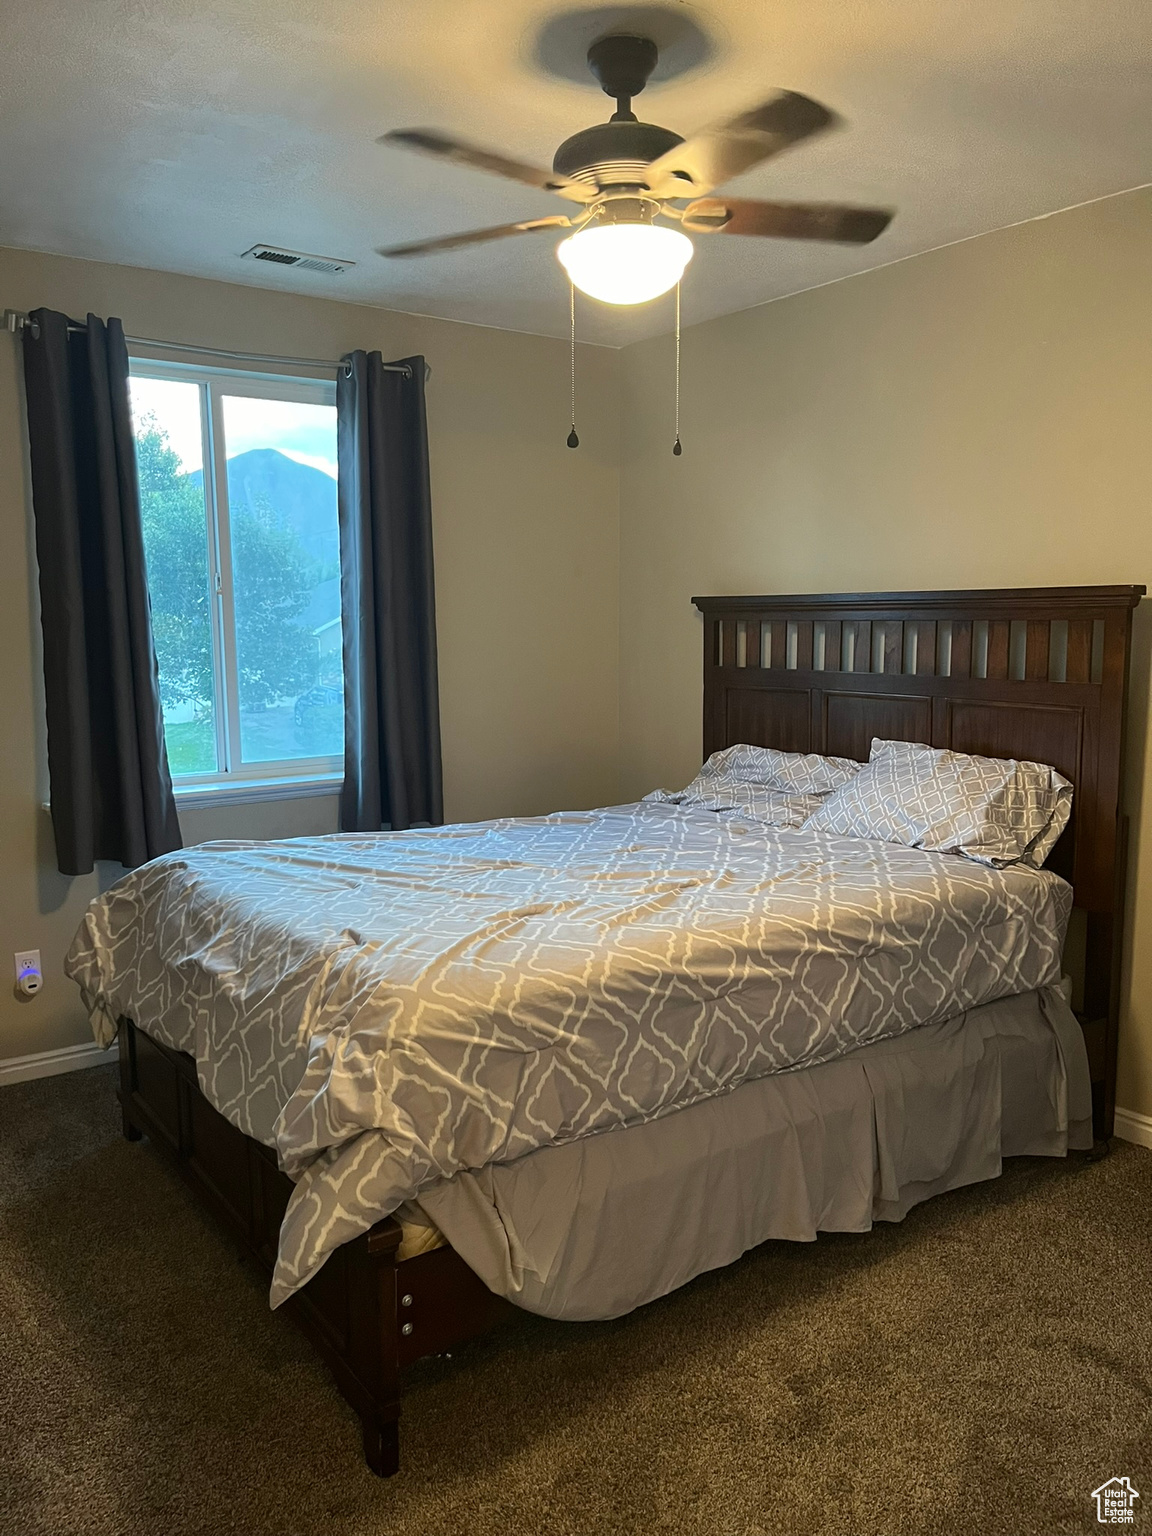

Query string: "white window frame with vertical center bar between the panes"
[129, 355, 344, 805]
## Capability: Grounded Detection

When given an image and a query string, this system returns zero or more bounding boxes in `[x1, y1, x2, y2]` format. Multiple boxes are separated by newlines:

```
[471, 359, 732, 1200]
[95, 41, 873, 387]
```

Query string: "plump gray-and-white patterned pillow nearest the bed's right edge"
[803, 740, 1072, 869]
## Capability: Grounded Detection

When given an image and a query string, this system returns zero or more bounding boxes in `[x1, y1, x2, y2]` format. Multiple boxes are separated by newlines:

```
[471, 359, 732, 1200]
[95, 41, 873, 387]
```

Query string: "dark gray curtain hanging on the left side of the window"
[25, 309, 180, 874]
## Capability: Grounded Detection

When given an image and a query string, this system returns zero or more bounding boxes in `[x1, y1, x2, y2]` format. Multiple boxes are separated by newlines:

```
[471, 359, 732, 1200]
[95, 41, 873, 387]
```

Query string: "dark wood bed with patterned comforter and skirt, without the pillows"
[74, 587, 1143, 1473]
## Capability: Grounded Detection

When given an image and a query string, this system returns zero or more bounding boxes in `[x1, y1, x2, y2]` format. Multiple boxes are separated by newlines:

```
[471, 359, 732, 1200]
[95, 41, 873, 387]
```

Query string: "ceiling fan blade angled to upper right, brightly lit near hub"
[645, 91, 839, 198]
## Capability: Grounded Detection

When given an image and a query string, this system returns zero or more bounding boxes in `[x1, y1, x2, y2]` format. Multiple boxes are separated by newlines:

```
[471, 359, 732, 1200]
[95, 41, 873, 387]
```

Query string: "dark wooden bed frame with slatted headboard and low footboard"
[112, 587, 1144, 1476]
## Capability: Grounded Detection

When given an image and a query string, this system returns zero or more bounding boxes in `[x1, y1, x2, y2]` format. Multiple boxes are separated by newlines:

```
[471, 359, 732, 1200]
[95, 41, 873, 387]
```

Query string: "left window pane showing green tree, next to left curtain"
[131, 376, 220, 776]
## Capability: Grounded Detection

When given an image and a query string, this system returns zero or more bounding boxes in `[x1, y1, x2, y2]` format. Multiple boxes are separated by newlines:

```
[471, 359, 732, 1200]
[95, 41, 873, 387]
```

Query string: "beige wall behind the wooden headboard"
[621, 192, 1152, 1115]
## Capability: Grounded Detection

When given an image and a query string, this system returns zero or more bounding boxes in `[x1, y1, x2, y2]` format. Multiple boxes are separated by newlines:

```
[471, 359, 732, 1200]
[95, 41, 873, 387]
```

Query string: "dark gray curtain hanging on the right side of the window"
[336, 352, 444, 833]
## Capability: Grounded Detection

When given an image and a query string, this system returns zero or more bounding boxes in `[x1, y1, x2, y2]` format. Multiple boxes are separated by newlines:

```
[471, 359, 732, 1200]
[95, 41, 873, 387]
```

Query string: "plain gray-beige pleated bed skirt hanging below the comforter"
[401, 988, 1092, 1319]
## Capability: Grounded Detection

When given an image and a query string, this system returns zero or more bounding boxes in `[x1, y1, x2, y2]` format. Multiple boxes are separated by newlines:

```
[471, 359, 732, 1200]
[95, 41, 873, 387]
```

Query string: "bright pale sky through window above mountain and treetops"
[131, 378, 336, 479]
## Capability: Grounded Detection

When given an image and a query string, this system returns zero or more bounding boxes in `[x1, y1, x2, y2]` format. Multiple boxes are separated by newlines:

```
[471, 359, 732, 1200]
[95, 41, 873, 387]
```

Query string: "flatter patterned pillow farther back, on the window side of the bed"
[645, 745, 863, 826]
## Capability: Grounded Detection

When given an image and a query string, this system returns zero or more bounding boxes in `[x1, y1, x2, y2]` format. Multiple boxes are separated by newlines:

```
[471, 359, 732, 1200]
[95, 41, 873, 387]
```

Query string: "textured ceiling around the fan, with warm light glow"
[0, 0, 1152, 344]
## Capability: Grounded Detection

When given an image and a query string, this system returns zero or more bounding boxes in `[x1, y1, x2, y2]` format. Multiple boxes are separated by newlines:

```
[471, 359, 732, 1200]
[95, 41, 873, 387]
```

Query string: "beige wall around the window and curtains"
[0, 250, 619, 1060]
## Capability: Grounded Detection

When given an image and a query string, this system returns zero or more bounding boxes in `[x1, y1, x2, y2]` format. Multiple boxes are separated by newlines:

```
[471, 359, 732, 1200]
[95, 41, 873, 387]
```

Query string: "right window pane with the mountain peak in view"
[221, 395, 344, 763]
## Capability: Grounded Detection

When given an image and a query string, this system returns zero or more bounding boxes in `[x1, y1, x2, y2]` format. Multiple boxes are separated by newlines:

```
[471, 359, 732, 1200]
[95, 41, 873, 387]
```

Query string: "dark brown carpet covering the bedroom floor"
[0, 1069, 1152, 1536]
